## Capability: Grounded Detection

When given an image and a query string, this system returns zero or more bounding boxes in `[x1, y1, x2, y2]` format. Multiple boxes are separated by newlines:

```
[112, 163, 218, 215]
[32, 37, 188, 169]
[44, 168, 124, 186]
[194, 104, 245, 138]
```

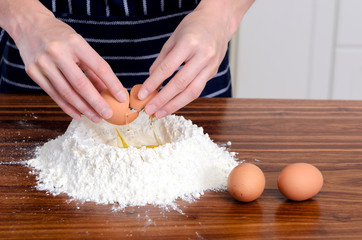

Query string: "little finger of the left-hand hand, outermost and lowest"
[26, 65, 81, 120]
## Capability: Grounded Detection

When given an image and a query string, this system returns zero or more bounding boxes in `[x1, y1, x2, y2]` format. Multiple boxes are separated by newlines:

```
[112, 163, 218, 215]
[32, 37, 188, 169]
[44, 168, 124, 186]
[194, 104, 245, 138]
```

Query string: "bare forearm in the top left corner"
[0, 0, 54, 40]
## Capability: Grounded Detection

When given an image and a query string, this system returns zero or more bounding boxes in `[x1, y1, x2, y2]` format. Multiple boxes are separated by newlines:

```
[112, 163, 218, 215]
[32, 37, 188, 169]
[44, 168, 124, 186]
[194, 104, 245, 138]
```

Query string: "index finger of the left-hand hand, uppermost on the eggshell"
[74, 38, 127, 102]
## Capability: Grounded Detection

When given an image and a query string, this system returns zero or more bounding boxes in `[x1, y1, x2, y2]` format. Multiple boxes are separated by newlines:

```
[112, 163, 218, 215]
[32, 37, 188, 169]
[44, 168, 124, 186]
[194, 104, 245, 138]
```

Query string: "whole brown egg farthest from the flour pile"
[278, 163, 323, 201]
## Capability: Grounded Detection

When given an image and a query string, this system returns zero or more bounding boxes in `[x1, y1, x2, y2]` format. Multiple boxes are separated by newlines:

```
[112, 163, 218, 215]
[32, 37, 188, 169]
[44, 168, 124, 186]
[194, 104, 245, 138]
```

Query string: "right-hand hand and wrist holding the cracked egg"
[138, 0, 252, 118]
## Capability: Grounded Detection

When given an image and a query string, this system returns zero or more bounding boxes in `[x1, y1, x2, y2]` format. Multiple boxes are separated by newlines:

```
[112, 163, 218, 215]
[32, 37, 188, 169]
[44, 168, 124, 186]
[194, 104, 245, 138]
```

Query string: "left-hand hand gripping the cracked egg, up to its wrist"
[11, 5, 127, 122]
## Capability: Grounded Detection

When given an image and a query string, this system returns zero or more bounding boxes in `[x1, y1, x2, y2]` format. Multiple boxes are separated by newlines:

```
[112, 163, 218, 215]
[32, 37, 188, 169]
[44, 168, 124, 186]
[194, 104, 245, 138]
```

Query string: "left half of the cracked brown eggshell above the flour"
[101, 89, 138, 125]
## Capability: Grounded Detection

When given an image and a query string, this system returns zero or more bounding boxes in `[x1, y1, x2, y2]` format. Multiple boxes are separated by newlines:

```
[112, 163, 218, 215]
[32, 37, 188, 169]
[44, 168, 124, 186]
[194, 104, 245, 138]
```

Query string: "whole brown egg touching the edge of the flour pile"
[227, 163, 265, 202]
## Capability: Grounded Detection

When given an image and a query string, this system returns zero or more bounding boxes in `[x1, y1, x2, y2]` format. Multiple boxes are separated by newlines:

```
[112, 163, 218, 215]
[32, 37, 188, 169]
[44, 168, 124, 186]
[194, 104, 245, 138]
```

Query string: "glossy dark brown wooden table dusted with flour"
[0, 95, 362, 239]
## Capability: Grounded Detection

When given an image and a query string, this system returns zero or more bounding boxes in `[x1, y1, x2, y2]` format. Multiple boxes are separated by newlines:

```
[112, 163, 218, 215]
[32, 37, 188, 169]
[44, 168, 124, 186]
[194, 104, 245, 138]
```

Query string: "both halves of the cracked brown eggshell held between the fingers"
[101, 84, 157, 125]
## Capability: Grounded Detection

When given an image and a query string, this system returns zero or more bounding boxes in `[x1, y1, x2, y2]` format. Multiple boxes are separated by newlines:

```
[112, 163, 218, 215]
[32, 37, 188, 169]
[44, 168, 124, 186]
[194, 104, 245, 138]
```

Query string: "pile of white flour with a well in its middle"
[28, 112, 237, 207]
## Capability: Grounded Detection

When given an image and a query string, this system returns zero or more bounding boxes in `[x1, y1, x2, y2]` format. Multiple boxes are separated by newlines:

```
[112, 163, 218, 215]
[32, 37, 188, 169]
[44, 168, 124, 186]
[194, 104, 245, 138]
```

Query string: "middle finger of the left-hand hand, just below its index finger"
[57, 54, 113, 119]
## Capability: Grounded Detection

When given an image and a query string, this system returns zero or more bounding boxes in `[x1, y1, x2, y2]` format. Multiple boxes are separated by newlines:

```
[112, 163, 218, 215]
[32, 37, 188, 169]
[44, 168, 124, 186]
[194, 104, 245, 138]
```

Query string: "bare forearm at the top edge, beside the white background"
[195, 0, 254, 38]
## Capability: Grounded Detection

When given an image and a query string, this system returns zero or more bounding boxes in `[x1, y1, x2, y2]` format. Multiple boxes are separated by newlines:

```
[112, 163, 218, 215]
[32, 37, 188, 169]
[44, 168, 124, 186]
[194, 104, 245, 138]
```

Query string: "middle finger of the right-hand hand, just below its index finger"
[145, 56, 205, 115]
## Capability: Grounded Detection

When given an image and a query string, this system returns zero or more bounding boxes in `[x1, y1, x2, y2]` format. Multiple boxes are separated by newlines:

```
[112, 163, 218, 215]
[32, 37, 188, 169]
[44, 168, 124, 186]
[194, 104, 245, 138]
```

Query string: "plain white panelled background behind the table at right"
[231, 0, 362, 99]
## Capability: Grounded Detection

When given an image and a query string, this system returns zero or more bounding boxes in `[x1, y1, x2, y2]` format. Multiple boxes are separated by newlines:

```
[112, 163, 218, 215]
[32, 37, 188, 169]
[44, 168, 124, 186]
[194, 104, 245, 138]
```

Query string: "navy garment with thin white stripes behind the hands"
[0, 0, 231, 97]
